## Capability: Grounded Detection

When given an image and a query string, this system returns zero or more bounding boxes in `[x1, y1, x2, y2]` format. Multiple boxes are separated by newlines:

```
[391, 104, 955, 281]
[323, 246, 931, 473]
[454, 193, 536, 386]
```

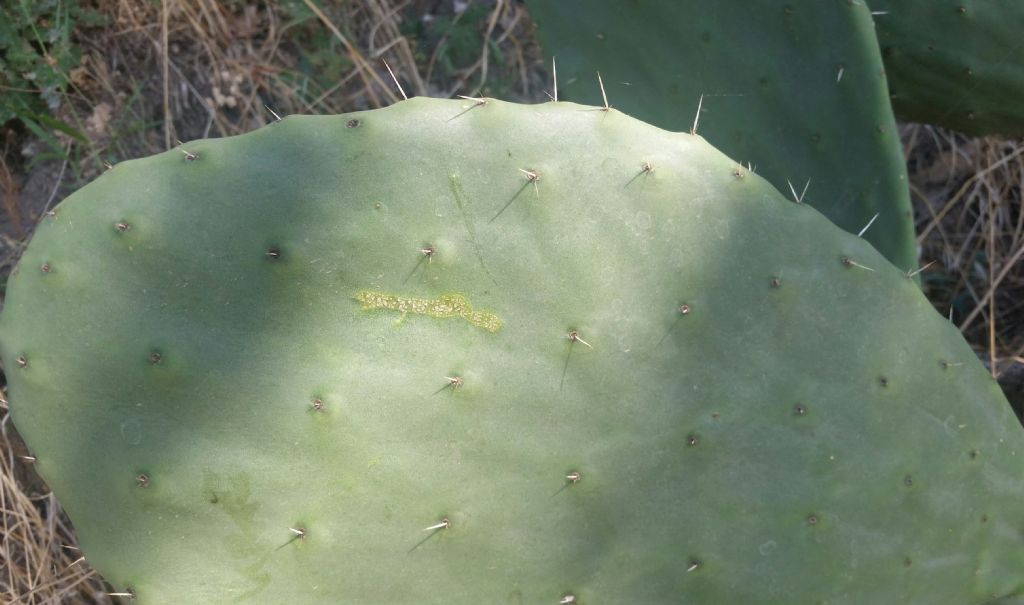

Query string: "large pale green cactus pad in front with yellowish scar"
[0, 99, 1024, 605]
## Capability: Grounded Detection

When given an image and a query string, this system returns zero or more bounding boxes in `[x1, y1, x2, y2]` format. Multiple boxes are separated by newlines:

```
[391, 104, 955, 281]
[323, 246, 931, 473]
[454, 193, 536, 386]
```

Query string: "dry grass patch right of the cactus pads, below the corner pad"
[903, 125, 1024, 416]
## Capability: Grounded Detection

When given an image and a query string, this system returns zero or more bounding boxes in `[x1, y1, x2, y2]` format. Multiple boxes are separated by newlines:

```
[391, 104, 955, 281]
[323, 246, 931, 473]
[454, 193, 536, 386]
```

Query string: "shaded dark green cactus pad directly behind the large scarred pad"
[527, 0, 918, 269]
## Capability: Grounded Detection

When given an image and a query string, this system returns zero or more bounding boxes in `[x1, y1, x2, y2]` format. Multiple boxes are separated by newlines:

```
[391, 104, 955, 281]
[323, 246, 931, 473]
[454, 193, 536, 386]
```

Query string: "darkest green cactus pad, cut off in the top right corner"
[870, 0, 1024, 136]
